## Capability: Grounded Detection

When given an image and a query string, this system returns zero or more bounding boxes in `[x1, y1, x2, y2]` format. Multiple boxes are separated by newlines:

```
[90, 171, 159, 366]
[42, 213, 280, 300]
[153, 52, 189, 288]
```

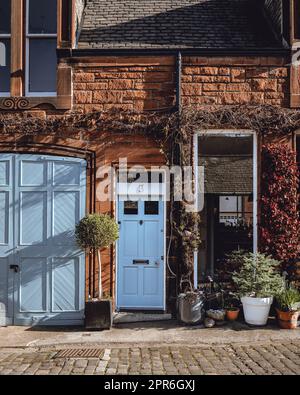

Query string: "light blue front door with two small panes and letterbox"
[117, 198, 165, 310]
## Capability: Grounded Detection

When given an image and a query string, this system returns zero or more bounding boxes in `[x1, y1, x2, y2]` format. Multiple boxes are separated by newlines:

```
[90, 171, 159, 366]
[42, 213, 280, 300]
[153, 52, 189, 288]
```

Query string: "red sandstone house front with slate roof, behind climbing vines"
[0, 0, 300, 325]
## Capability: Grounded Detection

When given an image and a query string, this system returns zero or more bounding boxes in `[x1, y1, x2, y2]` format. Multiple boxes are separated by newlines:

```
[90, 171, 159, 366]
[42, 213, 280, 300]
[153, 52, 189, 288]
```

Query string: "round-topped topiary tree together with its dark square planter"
[75, 214, 119, 329]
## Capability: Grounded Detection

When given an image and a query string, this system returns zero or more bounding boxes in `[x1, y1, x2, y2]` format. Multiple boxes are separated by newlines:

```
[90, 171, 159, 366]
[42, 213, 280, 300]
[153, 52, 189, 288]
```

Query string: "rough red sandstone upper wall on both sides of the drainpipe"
[73, 57, 289, 112]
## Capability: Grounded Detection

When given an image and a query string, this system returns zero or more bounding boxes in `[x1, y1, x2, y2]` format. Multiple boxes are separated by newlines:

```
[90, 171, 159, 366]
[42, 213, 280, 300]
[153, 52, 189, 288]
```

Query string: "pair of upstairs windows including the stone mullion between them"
[0, 0, 57, 97]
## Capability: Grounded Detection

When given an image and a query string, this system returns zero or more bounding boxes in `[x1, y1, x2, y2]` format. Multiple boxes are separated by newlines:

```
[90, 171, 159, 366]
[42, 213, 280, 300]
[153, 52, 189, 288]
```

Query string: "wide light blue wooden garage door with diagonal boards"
[0, 154, 86, 325]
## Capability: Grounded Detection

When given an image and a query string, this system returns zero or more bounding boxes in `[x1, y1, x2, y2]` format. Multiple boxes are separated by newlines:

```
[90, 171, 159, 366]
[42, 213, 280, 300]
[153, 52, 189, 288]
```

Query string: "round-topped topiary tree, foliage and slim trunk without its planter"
[75, 214, 119, 298]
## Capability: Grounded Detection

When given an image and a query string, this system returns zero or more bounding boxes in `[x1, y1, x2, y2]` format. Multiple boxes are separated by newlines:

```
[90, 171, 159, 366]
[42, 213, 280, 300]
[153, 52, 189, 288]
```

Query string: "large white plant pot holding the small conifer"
[241, 296, 273, 326]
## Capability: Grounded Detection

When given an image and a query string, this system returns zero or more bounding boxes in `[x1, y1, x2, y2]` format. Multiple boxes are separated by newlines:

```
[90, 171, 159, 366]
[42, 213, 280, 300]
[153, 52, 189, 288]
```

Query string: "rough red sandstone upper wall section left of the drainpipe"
[73, 57, 175, 112]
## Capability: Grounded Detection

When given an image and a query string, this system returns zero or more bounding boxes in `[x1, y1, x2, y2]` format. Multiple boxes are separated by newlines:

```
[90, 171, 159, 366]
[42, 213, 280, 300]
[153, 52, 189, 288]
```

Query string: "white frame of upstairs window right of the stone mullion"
[24, 0, 59, 97]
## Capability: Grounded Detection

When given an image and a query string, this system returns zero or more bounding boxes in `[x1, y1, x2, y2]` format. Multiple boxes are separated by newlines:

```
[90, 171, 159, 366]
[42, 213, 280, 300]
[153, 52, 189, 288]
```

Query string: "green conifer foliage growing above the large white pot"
[232, 253, 284, 298]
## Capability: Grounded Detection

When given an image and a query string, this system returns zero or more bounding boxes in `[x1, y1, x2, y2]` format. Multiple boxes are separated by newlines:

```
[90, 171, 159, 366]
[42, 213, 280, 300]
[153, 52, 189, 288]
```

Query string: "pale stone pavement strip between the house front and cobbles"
[0, 320, 300, 348]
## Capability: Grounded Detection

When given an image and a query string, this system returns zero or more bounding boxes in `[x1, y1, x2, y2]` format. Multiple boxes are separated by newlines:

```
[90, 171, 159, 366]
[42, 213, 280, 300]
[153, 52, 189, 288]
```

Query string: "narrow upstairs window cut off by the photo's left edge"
[0, 0, 11, 96]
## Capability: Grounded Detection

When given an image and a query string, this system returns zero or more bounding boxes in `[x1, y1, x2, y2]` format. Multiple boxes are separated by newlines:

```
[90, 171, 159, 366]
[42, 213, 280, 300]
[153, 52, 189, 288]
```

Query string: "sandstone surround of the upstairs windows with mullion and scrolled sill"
[0, 0, 72, 111]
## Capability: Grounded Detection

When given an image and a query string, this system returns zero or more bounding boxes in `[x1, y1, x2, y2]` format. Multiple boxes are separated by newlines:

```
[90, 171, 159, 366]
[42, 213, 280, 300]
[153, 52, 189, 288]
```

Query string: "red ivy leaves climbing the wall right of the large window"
[260, 143, 300, 274]
